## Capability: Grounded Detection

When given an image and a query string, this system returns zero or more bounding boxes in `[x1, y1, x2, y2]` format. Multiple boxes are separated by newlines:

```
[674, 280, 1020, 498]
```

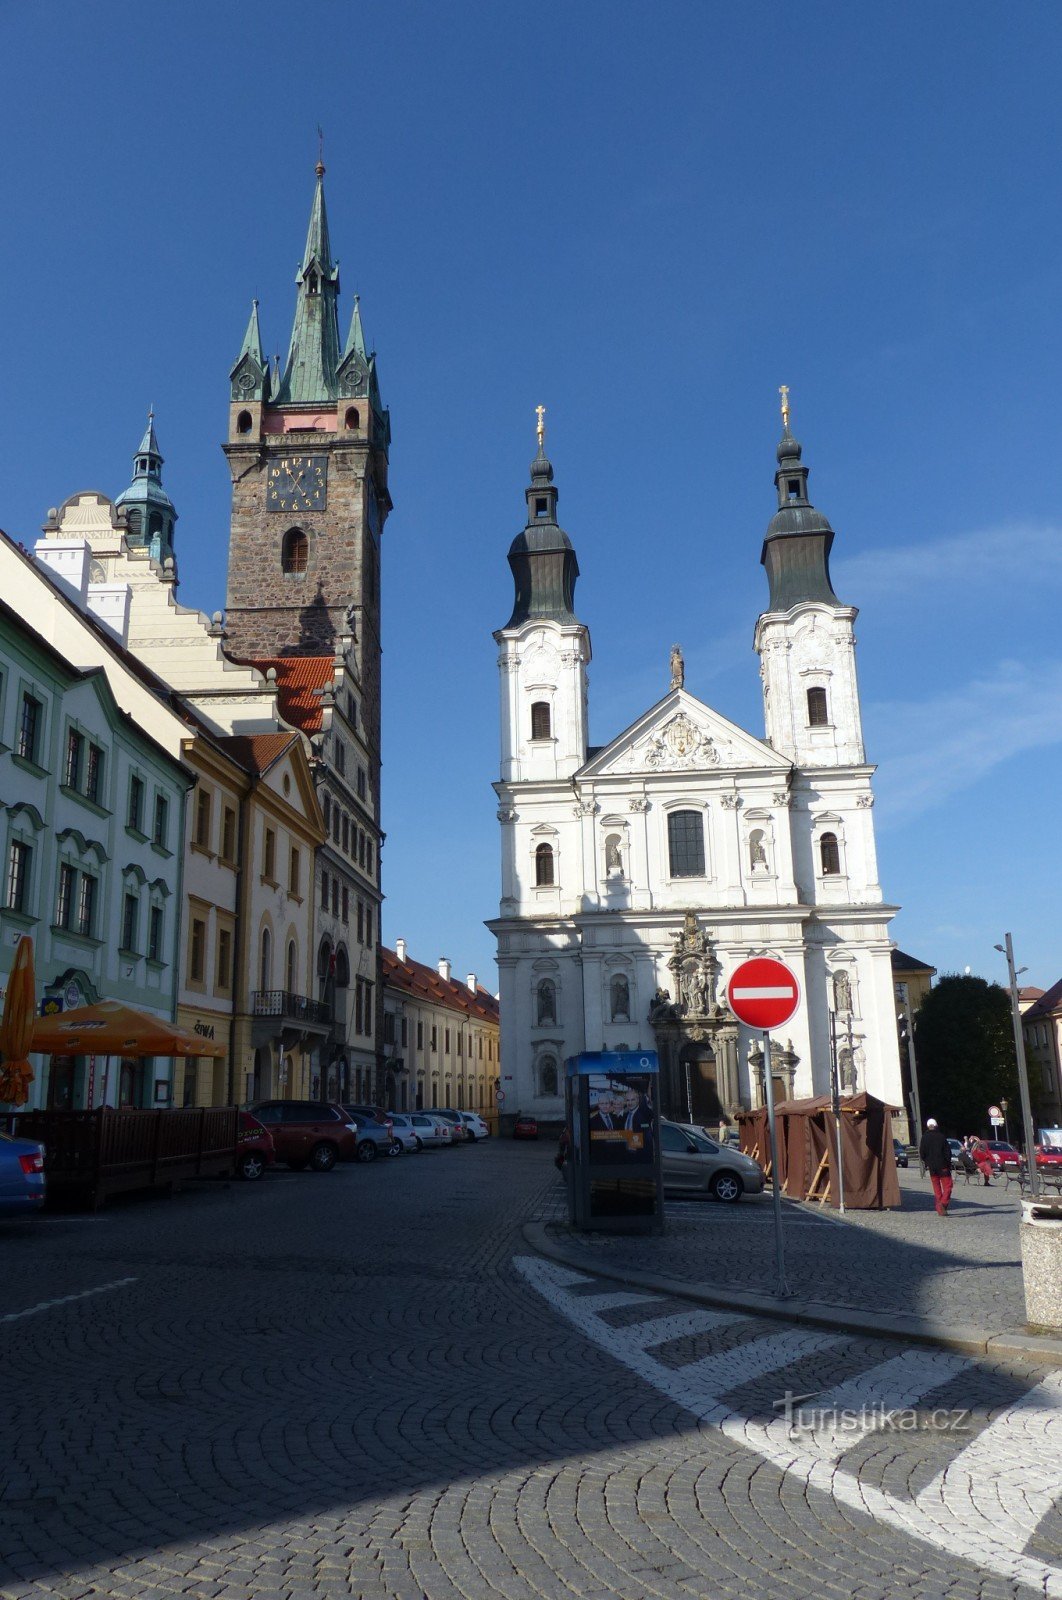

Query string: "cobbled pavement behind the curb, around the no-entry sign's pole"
[553, 1165, 1025, 1334]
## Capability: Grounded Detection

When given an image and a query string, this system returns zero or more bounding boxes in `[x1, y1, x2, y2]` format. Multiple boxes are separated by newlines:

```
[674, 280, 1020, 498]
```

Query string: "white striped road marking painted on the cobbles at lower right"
[515, 1256, 1062, 1600]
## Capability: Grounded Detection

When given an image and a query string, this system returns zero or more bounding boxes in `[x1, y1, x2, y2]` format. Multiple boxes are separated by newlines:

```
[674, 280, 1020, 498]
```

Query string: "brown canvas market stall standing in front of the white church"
[737, 1093, 900, 1211]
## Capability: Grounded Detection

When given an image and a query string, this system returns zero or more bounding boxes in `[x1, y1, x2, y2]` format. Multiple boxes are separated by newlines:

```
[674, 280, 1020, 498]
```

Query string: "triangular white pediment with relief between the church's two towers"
[579, 690, 789, 778]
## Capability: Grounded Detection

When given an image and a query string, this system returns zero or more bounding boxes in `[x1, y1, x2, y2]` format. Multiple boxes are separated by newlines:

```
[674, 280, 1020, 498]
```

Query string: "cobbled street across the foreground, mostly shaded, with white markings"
[0, 1141, 1062, 1600]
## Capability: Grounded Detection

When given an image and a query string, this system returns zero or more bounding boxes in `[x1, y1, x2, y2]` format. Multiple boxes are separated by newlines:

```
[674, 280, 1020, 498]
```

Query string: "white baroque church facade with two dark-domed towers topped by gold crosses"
[488, 405, 904, 1123]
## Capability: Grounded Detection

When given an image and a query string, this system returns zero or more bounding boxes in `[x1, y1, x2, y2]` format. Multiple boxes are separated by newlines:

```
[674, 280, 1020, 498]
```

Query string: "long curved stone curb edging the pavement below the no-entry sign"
[523, 1222, 1062, 1366]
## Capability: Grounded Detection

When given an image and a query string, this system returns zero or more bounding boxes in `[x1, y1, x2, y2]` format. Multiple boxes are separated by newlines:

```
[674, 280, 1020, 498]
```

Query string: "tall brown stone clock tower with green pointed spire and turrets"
[224, 162, 390, 736]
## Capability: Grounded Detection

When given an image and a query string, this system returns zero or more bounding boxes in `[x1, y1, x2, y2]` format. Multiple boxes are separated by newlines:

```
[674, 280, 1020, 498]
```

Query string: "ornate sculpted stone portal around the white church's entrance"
[649, 910, 798, 1128]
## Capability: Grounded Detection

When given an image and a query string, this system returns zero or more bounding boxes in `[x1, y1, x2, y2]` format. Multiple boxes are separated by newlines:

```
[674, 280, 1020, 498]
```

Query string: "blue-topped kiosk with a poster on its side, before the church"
[565, 1050, 664, 1232]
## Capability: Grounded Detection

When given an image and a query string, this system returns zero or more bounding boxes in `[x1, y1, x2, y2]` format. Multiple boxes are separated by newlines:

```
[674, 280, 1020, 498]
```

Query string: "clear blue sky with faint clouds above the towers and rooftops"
[0, 0, 1062, 986]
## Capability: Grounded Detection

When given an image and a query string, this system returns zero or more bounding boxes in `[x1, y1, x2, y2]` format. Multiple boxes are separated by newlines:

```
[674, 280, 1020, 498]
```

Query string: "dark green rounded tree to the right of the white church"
[915, 973, 1020, 1139]
